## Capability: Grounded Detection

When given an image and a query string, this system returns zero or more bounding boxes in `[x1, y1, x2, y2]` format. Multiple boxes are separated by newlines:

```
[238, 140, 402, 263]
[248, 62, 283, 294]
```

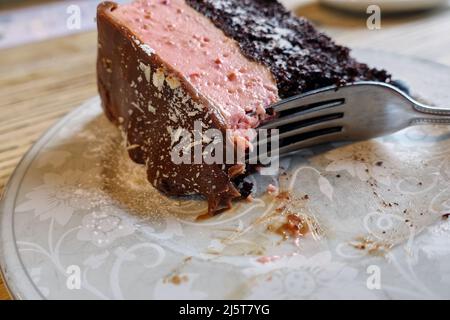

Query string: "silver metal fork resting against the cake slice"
[259, 82, 450, 156]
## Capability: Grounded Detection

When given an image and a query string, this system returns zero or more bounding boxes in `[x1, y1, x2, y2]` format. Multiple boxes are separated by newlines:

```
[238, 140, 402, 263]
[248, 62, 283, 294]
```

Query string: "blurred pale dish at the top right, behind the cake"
[319, 0, 447, 13]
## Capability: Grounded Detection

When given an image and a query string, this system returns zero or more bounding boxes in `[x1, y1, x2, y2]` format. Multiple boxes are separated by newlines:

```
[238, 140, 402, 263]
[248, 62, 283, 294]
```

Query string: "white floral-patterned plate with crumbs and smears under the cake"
[0, 51, 450, 299]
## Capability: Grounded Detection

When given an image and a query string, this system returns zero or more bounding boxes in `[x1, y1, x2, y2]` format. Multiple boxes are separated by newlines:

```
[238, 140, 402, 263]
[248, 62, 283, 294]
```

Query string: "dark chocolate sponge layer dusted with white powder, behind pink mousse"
[186, 0, 389, 98]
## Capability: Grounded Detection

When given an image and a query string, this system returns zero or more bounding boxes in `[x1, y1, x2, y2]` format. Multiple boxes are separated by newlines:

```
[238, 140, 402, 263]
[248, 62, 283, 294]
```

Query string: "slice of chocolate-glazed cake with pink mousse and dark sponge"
[97, 0, 389, 213]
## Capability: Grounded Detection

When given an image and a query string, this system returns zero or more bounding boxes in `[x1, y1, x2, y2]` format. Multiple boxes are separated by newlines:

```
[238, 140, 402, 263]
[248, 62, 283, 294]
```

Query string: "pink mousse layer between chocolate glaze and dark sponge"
[112, 0, 278, 129]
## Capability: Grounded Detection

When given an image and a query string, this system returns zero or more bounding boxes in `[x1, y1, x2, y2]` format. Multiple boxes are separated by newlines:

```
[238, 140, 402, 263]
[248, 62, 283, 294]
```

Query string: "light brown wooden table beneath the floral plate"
[0, 1, 450, 299]
